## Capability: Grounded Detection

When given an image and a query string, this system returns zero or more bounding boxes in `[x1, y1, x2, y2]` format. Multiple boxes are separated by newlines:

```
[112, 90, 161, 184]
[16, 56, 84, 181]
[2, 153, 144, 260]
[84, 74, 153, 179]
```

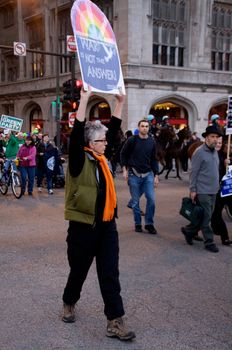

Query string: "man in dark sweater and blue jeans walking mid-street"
[121, 119, 159, 234]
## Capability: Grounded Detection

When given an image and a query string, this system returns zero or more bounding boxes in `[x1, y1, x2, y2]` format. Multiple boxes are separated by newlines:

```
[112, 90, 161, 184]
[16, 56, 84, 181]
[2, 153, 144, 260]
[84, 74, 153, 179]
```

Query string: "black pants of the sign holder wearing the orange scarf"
[63, 221, 124, 320]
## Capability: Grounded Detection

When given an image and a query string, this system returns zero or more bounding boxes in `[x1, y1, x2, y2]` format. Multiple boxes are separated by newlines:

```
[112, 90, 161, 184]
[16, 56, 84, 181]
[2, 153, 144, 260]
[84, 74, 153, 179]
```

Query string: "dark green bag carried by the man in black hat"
[180, 197, 204, 226]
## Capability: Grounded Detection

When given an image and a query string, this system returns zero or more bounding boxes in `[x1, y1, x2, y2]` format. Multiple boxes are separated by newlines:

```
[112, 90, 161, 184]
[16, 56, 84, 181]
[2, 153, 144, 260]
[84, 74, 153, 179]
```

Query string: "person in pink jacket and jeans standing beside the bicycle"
[17, 136, 36, 196]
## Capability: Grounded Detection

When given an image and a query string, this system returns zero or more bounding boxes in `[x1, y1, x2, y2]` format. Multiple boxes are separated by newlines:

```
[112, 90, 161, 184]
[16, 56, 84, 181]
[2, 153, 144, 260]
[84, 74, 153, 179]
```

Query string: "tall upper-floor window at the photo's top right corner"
[211, 3, 232, 71]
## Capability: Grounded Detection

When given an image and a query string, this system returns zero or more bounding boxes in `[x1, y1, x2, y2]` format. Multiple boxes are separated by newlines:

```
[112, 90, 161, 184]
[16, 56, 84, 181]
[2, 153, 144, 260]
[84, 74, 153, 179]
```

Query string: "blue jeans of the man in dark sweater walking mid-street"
[128, 170, 155, 225]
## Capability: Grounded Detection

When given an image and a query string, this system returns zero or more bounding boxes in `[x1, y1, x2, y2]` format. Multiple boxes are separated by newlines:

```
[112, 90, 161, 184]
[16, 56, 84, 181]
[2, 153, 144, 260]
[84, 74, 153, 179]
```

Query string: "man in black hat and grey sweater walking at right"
[181, 125, 222, 253]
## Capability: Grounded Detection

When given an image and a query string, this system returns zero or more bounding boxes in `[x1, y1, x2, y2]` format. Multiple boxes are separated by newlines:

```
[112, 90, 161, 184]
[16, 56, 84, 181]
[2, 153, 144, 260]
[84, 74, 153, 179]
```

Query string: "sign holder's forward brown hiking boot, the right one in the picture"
[106, 317, 135, 340]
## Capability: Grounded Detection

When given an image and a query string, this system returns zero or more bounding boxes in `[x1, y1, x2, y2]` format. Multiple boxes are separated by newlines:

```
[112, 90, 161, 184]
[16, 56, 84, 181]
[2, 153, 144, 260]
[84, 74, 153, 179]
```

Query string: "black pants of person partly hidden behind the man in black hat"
[211, 192, 229, 242]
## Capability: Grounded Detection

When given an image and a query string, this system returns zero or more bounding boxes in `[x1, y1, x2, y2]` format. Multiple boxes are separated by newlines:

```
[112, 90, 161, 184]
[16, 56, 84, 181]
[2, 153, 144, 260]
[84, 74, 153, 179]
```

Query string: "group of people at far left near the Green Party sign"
[0, 129, 63, 196]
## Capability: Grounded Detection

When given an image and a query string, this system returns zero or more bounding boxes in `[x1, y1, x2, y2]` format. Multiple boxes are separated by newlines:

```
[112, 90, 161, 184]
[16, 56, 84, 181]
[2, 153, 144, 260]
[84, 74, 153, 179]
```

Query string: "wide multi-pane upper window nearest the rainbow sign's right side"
[152, 0, 187, 67]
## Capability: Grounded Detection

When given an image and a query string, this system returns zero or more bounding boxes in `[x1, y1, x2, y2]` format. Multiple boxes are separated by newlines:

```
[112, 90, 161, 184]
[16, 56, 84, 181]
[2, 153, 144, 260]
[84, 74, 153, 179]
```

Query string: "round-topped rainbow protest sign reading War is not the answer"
[71, 0, 125, 94]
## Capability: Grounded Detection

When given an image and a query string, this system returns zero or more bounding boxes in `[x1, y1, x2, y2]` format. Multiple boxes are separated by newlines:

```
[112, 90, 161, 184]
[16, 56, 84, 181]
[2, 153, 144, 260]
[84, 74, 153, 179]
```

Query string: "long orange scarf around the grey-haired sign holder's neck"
[84, 147, 117, 221]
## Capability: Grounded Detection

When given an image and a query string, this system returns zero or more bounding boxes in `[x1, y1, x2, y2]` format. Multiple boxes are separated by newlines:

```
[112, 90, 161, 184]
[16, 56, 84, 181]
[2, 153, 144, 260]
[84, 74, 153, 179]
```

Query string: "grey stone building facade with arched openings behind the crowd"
[0, 0, 232, 144]
